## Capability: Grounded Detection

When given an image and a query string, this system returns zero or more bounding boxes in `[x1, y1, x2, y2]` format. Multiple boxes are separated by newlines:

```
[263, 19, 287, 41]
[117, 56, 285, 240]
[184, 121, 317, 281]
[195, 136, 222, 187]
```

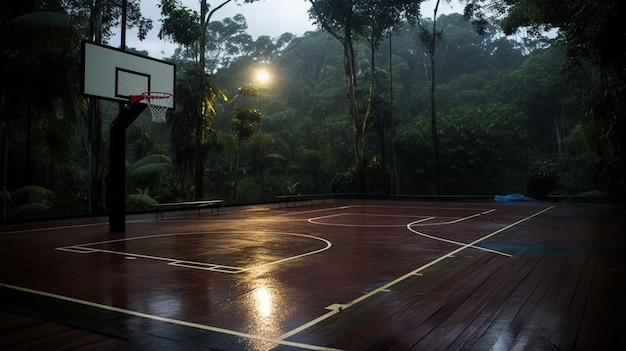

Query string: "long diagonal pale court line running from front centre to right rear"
[280, 206, 554, 339]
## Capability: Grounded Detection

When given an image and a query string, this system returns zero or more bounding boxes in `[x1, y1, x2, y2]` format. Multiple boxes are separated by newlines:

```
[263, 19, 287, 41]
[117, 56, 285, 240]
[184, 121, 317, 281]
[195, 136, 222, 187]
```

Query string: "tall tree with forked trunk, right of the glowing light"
[309, 0, 421, 192]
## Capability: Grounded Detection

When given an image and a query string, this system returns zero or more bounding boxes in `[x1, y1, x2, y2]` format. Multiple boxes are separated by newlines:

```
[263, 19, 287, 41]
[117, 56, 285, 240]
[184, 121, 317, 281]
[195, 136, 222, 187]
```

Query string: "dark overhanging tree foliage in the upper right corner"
[465, 0, 626, 196]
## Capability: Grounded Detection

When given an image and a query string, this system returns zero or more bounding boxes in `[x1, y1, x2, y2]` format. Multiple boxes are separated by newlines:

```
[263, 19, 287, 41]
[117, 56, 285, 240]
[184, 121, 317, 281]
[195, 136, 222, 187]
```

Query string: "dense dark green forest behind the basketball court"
[0, 0, 622, 220]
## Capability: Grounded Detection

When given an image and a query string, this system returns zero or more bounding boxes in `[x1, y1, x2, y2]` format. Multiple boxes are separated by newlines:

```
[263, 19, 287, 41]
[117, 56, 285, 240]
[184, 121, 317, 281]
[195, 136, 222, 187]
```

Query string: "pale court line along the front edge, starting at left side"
[0, 283, 338, 350]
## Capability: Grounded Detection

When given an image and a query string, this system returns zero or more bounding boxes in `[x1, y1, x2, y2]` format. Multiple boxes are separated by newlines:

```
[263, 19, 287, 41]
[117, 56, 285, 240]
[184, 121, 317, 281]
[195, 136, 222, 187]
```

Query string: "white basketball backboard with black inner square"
[82, 41, 176, 109]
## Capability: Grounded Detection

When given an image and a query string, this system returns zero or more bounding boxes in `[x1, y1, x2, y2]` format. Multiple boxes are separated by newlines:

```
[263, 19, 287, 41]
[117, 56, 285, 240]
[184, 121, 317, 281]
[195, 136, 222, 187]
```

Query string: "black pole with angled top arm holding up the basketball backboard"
[108, 103, 148, 232]
